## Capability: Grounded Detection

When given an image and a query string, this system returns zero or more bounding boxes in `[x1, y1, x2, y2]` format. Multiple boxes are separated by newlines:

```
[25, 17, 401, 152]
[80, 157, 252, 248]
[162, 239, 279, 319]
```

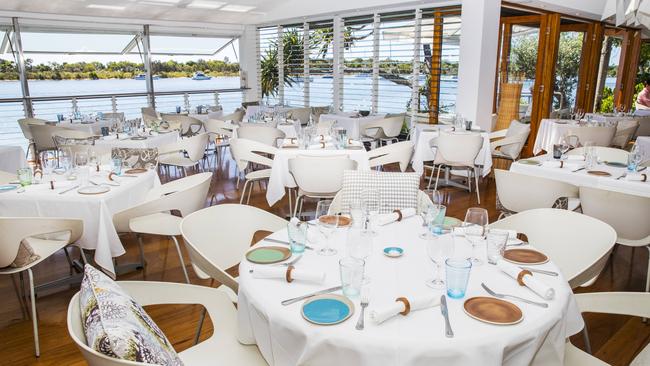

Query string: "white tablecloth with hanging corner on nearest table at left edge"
[0, 168, 160, 274]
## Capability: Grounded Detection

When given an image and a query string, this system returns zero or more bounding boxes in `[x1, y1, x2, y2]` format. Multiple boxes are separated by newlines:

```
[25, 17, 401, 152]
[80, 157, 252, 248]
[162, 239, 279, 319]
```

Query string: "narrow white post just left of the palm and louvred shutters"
[239, 25, 262, 102]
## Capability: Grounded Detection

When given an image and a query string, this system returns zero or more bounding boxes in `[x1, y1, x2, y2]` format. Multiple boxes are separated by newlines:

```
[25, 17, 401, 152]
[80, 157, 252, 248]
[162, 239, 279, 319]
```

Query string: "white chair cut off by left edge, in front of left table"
[0, 217, 85, 357]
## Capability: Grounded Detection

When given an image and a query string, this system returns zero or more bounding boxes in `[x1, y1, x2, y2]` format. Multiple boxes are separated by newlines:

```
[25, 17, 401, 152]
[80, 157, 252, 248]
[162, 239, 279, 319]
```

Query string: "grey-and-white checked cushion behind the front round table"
[341, 170, 420, 213]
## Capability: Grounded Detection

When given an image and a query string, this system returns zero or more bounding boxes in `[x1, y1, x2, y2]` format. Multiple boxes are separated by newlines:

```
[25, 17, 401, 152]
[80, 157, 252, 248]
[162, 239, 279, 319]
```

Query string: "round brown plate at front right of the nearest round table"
[463, 296, 524, 325]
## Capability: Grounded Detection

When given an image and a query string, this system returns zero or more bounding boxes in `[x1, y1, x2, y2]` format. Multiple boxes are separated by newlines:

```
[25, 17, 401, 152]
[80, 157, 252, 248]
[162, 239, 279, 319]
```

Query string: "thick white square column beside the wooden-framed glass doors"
[456, 0, 501, 131]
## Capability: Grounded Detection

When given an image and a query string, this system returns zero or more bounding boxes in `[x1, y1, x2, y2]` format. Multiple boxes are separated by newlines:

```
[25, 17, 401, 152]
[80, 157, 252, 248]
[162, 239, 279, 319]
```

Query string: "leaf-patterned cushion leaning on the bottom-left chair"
[79, 264, 183, 366]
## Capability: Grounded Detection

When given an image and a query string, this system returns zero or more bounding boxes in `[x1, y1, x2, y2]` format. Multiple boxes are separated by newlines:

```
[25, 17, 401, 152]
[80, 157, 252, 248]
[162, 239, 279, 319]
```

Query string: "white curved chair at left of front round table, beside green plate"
[181, 203, 287, 293]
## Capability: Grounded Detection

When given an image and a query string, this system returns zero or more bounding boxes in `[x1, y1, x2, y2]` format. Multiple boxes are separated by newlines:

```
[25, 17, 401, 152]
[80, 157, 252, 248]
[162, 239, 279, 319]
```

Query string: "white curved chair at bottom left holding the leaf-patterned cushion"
[67, 281, 267, 366]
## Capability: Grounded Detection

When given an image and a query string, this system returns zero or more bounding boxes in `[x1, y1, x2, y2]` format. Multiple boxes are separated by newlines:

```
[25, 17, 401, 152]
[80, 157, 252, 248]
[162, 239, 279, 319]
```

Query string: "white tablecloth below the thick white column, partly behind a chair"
[411, 125, 492, 177]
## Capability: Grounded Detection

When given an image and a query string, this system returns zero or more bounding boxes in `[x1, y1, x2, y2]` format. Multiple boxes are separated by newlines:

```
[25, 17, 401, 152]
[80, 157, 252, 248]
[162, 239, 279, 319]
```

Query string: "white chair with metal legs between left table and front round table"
[113, 173, 212, 283]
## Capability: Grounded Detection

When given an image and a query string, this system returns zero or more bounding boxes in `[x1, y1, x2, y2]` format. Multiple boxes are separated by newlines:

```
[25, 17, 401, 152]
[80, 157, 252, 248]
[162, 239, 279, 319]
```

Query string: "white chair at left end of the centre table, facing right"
[230, 138, 278, 204]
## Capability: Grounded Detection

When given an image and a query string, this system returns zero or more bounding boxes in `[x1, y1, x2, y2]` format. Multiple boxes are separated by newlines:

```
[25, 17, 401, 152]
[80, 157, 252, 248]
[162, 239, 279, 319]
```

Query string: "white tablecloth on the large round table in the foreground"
[238, 217, 584, 366]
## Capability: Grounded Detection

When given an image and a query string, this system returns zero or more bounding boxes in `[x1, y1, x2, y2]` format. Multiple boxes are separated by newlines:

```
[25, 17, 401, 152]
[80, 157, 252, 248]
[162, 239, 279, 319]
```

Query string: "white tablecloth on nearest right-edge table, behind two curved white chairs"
[510, 154, 650, 197]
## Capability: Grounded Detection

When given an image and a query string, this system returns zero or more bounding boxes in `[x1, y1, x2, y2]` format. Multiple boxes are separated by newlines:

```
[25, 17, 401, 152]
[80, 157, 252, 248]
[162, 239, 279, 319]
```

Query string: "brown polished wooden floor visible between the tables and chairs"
[0, 150, 650, 365]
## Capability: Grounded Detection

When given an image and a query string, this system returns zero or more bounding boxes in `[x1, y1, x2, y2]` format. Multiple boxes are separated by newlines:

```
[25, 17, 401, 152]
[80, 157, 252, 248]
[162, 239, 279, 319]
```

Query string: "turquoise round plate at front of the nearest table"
[301, 294, 354, 325]
